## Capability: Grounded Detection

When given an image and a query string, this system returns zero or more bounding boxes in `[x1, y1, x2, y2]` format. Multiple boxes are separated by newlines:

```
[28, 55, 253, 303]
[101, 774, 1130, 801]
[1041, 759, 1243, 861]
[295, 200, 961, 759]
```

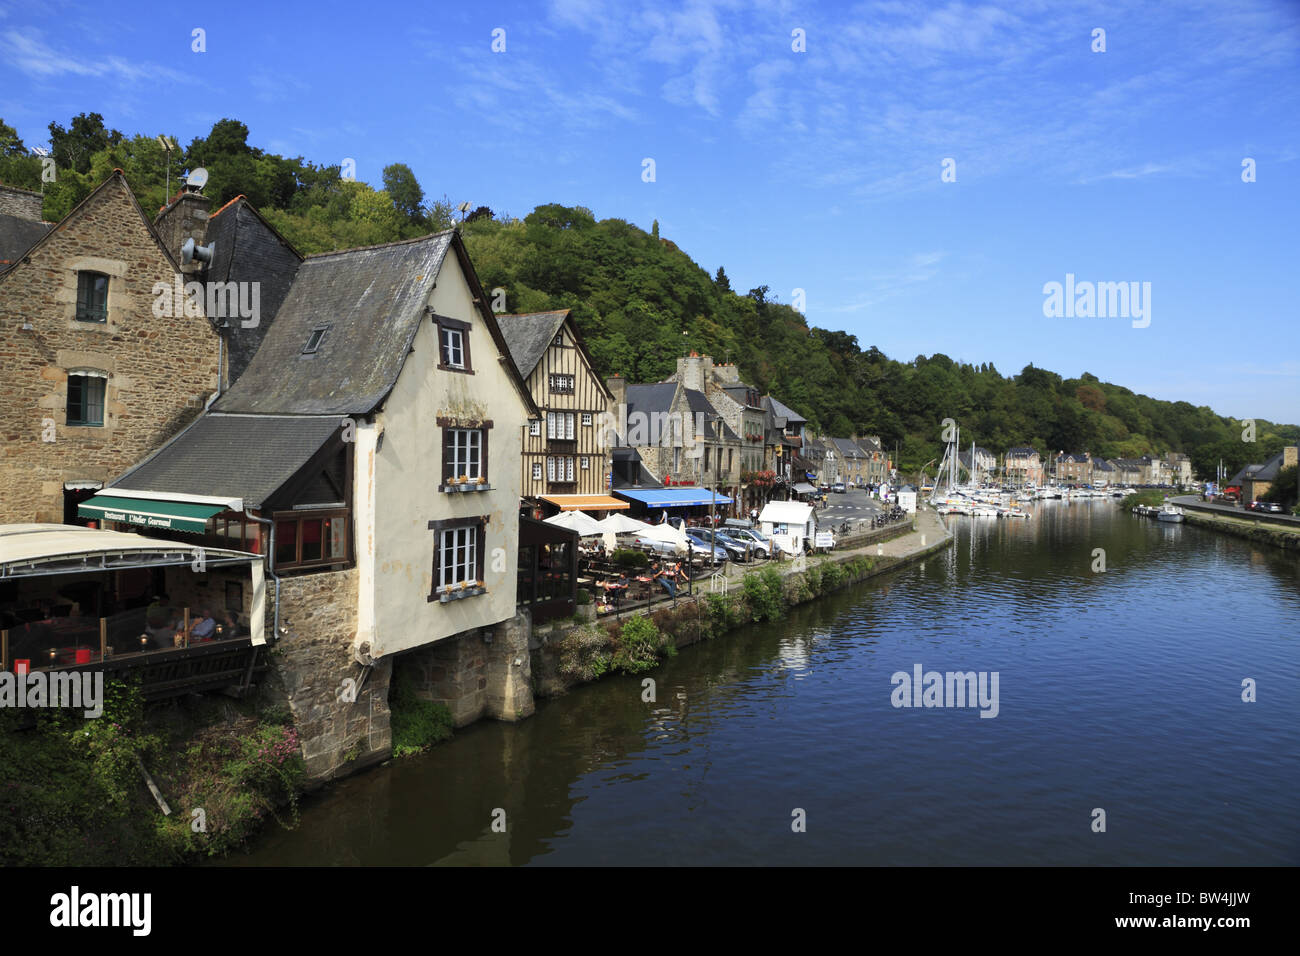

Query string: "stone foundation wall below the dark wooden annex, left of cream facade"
[267, 568, 393, 780]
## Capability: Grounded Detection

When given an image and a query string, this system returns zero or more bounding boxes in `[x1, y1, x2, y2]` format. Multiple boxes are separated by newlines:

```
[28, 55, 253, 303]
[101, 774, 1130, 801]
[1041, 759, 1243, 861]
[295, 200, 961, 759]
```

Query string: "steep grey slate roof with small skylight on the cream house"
[213, 230, 452, 415]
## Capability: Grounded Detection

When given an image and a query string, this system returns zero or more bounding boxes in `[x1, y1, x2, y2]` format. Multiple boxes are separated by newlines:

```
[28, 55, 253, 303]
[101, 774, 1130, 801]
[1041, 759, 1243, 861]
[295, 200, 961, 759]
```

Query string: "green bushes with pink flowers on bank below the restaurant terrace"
[0, 680, 306, 866]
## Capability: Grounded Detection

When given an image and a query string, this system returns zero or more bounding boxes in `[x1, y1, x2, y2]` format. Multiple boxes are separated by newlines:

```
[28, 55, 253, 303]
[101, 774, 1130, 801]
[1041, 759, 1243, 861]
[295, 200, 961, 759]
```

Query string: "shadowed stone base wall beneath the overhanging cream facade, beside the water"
[397, 613, 534, 727]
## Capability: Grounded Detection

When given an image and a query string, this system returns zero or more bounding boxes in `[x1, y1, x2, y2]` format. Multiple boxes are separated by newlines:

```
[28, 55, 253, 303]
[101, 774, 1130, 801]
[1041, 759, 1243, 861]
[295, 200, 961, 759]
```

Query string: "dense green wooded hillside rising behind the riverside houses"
[0, 113, 1300, 475]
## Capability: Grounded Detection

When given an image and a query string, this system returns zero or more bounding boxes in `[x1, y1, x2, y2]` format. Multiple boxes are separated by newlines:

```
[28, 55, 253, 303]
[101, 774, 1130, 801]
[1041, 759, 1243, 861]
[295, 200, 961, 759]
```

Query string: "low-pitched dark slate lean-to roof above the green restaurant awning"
[109, 412, 345, 509]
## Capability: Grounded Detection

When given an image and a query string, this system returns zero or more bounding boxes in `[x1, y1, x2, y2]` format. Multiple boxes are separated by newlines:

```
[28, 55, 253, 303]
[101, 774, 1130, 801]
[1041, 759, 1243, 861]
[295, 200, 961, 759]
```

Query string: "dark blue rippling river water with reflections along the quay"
[226, 499, 1300, 865]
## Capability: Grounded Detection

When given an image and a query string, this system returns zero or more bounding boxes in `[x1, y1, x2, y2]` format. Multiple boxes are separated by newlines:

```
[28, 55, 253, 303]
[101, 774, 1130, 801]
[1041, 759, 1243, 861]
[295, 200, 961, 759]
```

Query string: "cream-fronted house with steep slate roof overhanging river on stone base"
[76, 230, 538, 777]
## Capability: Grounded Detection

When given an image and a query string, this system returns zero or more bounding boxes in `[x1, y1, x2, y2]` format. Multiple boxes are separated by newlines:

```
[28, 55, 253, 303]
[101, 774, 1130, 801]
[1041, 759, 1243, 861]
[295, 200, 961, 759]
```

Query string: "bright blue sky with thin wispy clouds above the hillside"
[0, 0, 1300, 423]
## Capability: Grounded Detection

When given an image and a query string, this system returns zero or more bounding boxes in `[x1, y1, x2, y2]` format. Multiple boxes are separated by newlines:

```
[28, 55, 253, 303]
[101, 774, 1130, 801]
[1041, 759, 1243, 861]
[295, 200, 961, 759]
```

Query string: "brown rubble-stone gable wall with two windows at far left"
[0, 173, 218, 523]
